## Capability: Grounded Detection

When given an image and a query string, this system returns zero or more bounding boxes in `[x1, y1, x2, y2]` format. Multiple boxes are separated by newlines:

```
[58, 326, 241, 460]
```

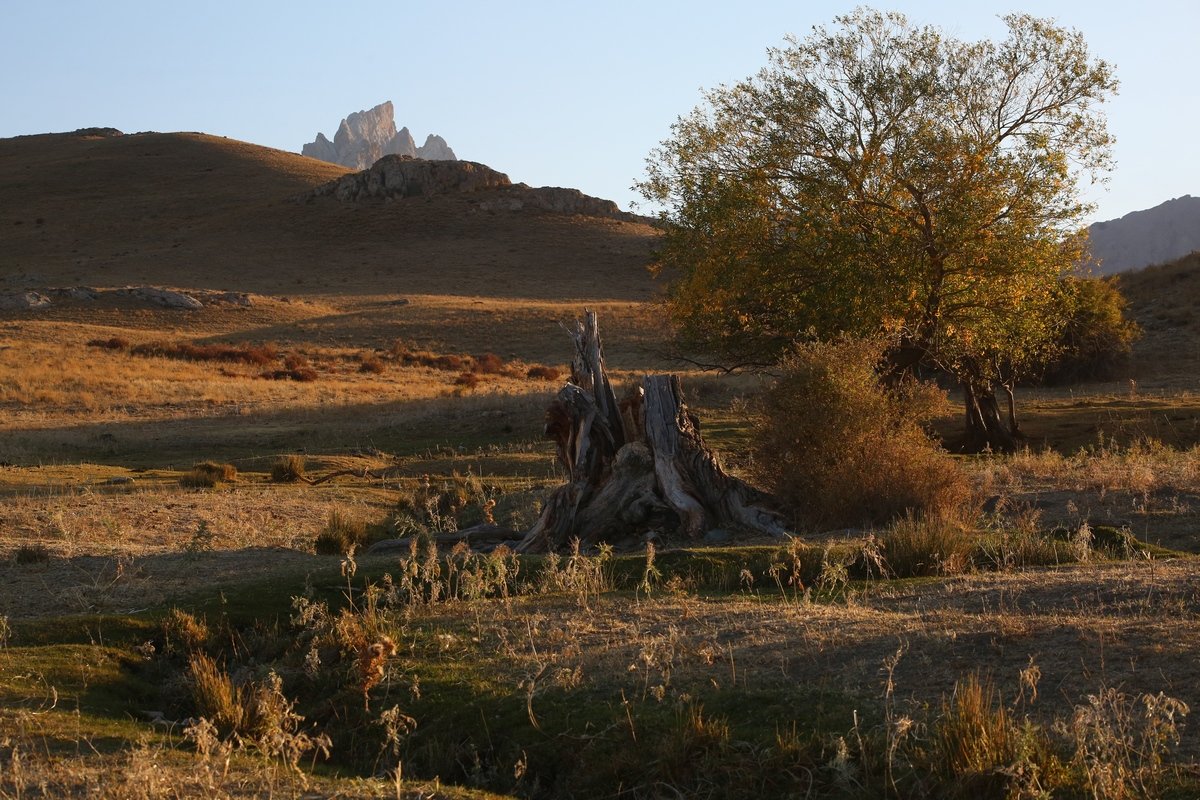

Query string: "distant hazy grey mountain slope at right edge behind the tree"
[1087, 194, 1200, 275]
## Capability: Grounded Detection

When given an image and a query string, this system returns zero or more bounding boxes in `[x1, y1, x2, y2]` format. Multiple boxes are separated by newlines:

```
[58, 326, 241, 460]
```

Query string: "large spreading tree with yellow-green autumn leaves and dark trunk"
[640, 8, 1116, 450]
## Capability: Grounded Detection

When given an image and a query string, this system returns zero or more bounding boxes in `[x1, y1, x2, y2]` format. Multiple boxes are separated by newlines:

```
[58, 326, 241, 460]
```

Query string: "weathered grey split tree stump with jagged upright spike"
[516, 311, 787, 553]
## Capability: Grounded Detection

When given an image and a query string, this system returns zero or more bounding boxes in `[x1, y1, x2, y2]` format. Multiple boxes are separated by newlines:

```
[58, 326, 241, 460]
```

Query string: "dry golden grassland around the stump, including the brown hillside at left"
[0, 133, 1200, 800]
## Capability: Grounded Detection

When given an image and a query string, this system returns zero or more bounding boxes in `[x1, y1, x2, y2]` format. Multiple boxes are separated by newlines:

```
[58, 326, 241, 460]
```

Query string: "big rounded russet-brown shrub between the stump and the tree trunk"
[752, 338, 971, 527]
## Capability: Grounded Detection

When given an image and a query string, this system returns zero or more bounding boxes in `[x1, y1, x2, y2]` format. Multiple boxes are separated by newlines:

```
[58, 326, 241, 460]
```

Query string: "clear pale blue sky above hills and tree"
[0, 0, 1200, 225]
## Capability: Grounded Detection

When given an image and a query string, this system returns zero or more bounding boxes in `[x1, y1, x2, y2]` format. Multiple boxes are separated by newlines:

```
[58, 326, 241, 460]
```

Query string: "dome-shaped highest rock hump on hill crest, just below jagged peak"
[300, 156, 511, 203]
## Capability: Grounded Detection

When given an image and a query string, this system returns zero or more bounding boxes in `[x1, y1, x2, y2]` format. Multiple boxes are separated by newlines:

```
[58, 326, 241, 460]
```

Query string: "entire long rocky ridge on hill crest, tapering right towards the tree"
[296, 156, 647, 222]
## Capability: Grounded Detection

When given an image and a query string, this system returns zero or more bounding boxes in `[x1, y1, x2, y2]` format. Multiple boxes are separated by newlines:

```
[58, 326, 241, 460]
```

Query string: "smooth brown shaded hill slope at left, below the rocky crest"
[0, 133, 655, 301]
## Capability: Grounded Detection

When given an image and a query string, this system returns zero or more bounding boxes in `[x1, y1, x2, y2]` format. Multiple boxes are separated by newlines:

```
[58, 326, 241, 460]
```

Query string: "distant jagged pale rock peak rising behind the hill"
[300, 101, 456, 169]
